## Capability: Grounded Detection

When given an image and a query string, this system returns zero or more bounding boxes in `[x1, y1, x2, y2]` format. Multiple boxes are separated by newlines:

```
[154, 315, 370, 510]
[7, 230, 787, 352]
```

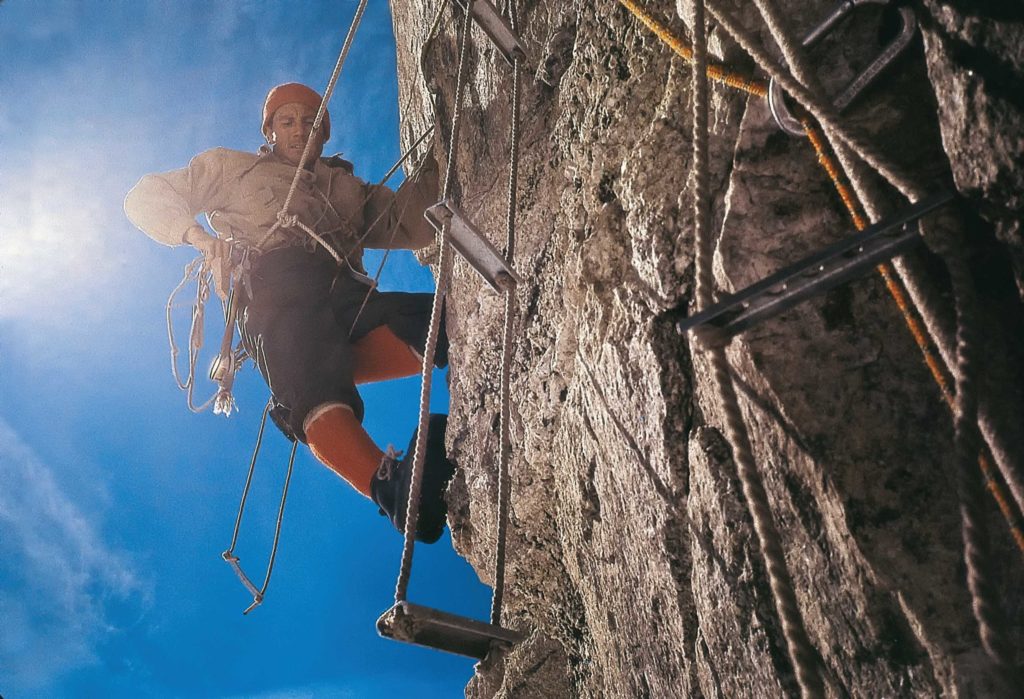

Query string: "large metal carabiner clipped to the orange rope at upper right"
[768, 0, 918, 136]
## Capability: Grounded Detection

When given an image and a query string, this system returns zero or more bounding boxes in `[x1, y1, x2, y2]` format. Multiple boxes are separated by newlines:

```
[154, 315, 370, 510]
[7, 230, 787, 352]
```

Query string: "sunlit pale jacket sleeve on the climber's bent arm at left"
[125, 148, 230, 246]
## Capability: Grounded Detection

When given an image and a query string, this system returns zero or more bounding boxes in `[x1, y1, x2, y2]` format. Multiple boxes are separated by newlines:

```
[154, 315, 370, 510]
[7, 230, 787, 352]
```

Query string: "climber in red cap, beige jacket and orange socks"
[125, 83, 453, 542]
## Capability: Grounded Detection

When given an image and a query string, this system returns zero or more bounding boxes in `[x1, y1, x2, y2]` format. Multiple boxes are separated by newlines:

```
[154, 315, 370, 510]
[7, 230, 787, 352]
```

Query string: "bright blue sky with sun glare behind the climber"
[0, 0, 489, 699]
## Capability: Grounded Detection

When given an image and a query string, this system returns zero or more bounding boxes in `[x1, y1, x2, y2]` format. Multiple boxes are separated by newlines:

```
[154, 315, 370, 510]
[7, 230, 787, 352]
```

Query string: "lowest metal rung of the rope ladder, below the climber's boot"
[377, 602, 525, 660]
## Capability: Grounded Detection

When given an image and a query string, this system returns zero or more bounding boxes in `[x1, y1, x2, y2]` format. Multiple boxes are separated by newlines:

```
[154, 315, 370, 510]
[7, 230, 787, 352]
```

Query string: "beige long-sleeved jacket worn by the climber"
[125, 148, 437, 259]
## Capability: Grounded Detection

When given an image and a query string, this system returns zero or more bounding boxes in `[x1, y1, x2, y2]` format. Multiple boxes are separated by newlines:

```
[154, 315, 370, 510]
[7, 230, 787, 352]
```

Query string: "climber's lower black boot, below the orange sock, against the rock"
[370, 414, 455, 543]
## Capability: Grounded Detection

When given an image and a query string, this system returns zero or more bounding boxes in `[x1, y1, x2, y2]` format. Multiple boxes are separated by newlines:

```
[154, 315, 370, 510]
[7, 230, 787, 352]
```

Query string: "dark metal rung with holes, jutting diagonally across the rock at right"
[678, 192, 953, 339]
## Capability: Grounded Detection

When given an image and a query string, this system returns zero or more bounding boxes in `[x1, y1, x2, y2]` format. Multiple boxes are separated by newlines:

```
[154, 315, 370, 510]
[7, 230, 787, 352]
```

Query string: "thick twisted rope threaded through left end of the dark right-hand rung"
[692, 0, 824, 699]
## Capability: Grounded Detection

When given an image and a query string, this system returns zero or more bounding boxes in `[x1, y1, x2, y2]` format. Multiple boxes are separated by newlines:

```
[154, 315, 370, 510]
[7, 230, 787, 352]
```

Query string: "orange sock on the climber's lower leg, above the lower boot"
[302, 403, 384, 497]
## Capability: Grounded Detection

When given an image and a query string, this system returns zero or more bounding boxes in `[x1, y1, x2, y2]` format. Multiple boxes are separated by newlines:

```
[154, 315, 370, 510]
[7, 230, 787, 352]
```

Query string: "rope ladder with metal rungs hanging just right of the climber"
[377, 0, 524, 660]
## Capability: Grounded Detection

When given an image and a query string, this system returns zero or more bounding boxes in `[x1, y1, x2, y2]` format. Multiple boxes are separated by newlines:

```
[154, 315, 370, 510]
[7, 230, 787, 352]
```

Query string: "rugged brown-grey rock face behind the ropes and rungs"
[391, 0, 1024, 699]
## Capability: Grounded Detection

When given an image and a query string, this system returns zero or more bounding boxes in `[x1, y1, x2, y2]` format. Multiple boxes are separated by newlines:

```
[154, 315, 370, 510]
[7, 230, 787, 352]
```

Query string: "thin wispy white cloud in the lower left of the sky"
[0, 419, 150, 694]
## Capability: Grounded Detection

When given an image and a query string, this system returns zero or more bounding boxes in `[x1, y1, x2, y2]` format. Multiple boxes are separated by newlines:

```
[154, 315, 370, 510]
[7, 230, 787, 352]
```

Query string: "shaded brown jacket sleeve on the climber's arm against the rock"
[362, 157, 437, 250]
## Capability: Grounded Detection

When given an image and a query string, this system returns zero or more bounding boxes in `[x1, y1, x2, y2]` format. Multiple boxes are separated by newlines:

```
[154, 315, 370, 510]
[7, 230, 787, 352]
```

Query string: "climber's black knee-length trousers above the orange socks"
[239, 248, 447, 442]
